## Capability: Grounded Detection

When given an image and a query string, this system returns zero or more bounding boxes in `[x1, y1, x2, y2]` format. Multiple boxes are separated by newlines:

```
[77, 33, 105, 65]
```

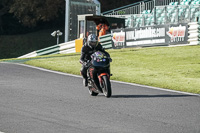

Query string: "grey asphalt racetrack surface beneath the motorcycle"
[0, 63, 200, 133]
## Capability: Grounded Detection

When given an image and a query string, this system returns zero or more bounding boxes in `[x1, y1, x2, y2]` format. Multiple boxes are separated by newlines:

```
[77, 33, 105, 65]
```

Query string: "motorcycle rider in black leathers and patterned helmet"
[80, 34, 110, 87]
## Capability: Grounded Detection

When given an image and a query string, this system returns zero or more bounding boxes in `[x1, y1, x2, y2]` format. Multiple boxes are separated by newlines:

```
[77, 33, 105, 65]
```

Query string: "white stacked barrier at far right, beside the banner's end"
[188, 22, 200, 45]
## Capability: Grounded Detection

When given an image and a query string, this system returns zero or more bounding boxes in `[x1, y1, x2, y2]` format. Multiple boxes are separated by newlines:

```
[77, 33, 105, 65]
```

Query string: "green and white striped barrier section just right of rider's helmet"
[99, 34, 113, 49]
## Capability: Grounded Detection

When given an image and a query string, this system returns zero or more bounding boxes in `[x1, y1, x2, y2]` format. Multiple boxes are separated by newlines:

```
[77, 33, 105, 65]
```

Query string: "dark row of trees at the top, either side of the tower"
[0, 0, 139, 34]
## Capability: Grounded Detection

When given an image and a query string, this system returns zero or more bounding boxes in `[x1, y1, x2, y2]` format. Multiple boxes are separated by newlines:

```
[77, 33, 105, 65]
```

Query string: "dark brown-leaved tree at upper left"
[9, 0, 65, 27]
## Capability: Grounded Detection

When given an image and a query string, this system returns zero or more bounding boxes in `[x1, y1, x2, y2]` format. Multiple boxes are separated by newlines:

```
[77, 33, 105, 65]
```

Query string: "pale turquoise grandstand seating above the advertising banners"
[126, 5, 200, 28]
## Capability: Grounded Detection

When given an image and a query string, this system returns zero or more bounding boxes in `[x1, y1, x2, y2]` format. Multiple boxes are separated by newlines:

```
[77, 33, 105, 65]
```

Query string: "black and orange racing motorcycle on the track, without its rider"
[87, 51, 112, 98]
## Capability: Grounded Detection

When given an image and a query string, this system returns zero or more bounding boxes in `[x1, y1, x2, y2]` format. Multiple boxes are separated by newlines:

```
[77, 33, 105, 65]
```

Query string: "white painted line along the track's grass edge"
[0, 62, 200, 96]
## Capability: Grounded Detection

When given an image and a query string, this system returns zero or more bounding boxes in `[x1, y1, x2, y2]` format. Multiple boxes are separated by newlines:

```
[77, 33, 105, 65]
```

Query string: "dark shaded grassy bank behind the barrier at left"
[0, 29, 64, 59]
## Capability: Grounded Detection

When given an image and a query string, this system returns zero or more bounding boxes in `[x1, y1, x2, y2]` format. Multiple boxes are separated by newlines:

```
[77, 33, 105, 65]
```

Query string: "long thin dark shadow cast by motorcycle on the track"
[111, 94, 192, 98]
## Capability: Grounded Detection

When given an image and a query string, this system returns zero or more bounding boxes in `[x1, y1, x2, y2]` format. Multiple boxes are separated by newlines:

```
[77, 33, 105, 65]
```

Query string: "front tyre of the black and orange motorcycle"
[102, 75, 112, 98]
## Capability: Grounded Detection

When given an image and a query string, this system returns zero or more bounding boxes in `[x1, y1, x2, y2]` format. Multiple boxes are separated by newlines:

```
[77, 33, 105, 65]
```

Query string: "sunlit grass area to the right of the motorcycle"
[109, 46, 200, 93]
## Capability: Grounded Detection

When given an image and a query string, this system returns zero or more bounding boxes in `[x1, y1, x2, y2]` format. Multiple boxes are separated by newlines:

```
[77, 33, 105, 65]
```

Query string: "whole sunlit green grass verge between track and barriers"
[1, 46, 200, 94]
